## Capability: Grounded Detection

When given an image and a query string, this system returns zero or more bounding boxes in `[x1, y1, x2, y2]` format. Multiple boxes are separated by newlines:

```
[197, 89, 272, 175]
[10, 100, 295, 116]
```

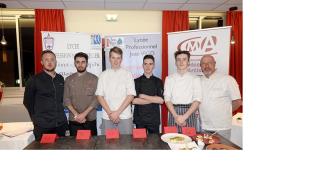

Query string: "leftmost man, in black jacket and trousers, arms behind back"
[23, 50, 68, 141]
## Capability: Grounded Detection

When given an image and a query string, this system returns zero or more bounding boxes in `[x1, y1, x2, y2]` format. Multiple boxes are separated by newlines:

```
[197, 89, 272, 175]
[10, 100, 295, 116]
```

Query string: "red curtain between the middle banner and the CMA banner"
[161, 11, 189, 131]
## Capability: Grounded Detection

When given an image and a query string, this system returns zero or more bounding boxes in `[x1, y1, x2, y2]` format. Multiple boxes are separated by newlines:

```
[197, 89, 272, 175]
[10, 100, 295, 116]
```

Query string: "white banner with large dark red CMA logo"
[168, 26, 231, 75]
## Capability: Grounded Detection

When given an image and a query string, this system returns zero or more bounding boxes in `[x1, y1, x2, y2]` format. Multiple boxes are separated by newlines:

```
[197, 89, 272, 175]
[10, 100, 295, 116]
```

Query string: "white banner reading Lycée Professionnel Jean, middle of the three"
[105, 33, 162, 78]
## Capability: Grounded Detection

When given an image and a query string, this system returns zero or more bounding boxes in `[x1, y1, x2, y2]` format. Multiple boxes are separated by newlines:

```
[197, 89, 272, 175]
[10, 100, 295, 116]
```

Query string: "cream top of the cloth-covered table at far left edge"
[0, 122, 33, 137]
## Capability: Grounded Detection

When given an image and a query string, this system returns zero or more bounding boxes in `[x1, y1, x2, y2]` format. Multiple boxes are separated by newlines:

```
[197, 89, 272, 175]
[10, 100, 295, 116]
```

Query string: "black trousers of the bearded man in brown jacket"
[69, 120, 97, 136]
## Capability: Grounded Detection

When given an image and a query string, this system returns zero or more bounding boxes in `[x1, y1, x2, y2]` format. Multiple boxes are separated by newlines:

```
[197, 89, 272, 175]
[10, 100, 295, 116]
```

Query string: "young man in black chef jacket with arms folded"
[132, 55, 164, 133]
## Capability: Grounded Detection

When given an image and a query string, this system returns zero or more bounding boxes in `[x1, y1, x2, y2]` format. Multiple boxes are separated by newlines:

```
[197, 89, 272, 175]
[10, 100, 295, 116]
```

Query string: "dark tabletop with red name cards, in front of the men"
[24, 134, 241, 150]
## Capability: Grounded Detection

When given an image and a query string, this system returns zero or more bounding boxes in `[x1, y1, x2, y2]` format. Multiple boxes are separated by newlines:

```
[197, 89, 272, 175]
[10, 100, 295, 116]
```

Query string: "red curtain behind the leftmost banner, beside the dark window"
[34, 9, 65, 73]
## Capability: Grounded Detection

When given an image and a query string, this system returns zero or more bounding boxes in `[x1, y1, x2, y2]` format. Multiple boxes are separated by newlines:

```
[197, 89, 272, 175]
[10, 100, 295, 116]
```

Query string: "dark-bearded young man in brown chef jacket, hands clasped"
[63, 52, 98, 136]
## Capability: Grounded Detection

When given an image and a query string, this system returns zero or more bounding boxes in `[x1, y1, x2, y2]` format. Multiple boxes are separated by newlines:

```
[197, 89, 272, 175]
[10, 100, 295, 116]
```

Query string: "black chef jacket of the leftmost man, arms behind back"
[23, 71, 67, 128]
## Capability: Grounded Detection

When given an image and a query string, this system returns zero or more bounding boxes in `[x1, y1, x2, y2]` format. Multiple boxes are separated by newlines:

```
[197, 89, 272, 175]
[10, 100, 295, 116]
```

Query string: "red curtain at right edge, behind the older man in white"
[227, 11, 243, 112]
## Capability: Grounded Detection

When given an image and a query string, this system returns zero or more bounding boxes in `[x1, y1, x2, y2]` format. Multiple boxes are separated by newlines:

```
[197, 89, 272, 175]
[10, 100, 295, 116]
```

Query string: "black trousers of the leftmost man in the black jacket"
[33, 123, 68, 141]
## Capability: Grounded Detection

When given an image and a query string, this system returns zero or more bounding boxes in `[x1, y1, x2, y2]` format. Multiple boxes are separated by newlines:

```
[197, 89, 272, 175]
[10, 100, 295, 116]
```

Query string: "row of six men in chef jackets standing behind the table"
[23, 47, 242, 140]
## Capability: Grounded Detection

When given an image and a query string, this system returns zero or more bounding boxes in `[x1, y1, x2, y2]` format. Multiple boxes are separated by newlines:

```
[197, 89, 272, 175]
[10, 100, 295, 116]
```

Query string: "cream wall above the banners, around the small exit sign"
[64, 10, 162, 36]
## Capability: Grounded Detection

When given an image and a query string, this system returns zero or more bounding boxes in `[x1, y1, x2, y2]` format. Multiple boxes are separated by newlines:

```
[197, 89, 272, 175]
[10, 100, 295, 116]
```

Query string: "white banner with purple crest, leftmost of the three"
[42, 32, 102, 78]
